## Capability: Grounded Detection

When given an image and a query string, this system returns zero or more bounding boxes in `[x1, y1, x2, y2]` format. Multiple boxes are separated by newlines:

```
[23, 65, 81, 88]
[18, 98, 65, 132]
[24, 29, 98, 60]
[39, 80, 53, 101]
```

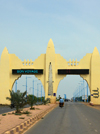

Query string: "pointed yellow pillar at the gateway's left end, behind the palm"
[0, 47, 10, 104]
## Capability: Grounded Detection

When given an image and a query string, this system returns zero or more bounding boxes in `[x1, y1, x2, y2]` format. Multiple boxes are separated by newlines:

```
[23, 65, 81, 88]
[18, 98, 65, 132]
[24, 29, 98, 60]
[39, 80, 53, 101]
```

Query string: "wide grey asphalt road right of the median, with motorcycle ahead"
[24, 102, 100, 134]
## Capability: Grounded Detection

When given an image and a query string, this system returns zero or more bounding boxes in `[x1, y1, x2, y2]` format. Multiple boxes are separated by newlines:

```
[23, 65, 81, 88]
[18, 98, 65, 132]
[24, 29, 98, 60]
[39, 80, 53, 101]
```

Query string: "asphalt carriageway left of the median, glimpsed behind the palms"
[0, 102, 41, 114]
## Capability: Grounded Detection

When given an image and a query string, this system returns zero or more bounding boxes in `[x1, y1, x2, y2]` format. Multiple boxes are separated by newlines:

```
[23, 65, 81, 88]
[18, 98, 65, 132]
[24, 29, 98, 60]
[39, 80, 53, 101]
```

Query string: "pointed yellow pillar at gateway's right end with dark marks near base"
[90, 47, 100, 105]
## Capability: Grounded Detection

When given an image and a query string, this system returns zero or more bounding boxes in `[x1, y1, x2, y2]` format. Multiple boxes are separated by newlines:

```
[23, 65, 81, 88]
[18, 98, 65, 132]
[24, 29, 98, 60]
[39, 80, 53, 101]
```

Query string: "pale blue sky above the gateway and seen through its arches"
[0, 0, 100, 99]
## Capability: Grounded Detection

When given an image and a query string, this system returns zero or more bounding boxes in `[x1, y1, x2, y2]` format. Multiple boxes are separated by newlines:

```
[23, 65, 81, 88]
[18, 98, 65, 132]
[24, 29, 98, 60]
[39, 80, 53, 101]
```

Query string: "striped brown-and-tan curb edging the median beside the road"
[4, 104, 58, 134]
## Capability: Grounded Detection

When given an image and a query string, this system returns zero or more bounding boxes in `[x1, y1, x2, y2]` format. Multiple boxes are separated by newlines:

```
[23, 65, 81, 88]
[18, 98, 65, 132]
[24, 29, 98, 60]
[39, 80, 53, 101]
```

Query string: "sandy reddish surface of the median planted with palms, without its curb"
[0, 104, 56, 134]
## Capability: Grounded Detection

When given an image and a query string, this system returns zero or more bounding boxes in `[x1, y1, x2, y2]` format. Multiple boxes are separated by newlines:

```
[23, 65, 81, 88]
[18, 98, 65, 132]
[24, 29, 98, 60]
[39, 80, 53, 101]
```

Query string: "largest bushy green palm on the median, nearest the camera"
[6, 90, 27, 113]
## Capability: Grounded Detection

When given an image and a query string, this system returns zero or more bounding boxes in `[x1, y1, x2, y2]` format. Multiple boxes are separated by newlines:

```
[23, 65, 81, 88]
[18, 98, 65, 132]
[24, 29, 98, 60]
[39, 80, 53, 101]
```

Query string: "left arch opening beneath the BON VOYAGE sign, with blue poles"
[12, 75, 45, 101]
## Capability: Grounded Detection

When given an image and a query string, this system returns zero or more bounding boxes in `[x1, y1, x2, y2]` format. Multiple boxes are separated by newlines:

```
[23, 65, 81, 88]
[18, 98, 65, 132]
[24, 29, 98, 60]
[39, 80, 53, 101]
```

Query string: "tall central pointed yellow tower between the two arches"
[45, 39, 56, 103]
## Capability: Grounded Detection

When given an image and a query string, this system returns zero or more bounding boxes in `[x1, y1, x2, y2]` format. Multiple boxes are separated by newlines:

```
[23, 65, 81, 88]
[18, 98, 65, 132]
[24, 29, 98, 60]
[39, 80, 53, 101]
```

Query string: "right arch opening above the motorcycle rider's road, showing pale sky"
[57, 75, 90, 101]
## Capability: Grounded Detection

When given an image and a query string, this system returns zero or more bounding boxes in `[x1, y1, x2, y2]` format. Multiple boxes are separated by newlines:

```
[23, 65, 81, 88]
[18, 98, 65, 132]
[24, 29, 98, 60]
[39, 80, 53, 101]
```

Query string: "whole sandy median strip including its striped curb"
[0, 104, 58, 134]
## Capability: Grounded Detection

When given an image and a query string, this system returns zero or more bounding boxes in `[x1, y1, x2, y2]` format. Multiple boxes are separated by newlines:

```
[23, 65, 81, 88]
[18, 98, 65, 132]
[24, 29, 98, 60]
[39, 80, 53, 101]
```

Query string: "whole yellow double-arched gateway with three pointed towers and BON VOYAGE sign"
[0, 39, 100, 104]
